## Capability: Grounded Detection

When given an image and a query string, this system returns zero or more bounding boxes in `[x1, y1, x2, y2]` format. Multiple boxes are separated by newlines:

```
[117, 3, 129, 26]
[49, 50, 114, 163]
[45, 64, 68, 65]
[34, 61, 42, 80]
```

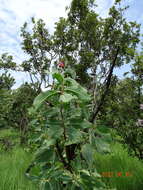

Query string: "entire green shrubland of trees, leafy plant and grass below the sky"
[0, 0, 143, 190]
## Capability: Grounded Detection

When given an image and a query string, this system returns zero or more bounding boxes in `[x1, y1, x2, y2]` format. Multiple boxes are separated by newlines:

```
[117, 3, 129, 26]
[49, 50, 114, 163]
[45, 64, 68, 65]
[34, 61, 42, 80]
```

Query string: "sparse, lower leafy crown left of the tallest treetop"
[21, 18, 53, 91]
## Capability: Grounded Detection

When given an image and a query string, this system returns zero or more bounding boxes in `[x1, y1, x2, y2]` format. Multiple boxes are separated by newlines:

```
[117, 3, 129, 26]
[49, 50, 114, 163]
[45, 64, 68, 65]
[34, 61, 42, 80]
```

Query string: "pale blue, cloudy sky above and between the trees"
[0, 0, 143, 87]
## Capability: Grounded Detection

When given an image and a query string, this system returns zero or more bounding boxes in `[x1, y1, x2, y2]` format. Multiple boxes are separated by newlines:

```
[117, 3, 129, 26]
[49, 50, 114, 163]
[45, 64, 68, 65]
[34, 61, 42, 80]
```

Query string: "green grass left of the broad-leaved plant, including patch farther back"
[0, 128, 37, 190]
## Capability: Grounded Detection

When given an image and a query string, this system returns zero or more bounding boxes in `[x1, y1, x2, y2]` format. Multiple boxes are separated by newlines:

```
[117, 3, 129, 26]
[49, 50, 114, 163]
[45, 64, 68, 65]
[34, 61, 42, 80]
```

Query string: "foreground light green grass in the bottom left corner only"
[0, 147, 37, 190]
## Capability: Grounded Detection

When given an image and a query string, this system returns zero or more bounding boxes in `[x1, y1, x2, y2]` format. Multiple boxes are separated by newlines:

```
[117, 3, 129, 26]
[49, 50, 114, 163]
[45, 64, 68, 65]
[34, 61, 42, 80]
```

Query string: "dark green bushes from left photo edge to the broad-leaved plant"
[0, 83, 37, 143]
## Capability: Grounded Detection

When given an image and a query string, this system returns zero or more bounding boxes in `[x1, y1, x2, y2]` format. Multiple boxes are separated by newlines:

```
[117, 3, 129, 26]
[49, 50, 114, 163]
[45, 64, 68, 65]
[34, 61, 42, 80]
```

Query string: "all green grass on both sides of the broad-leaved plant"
[0, 130, 143, 190]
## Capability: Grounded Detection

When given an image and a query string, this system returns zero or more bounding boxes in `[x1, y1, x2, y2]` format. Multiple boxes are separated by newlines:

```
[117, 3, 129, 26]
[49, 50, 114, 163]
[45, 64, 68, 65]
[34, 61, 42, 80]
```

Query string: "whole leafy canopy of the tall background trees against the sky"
[16, 0, 140, 104]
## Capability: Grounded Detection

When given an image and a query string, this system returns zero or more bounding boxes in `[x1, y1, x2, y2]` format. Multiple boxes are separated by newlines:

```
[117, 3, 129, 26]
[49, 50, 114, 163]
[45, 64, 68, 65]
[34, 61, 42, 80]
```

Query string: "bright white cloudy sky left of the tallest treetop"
[0, 0, 70, 53]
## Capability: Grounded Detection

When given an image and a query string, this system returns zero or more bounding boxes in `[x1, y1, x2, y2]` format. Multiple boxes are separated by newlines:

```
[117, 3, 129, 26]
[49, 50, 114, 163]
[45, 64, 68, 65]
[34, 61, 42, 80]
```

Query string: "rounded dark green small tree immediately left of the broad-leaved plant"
[9, 83, 37, 144]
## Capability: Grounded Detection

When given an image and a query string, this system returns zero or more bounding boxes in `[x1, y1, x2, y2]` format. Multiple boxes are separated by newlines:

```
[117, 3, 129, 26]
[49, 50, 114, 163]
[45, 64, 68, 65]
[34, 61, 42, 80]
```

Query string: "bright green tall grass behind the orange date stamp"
[95, 143, 143, 190]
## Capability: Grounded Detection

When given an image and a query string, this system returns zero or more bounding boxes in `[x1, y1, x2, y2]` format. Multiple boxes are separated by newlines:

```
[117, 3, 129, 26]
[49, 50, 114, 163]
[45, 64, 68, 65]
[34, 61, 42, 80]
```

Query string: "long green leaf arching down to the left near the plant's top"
[33, 90, 59, 109]
